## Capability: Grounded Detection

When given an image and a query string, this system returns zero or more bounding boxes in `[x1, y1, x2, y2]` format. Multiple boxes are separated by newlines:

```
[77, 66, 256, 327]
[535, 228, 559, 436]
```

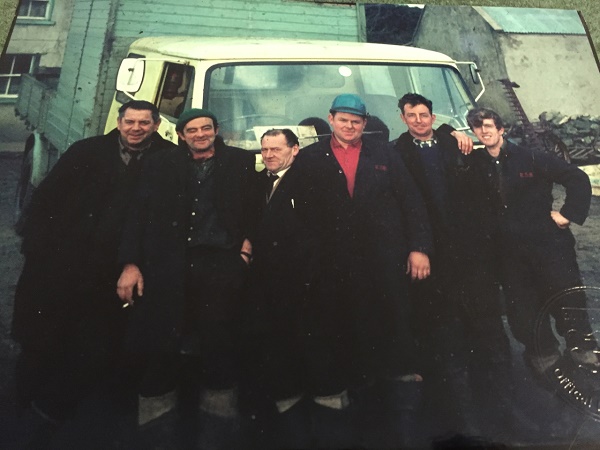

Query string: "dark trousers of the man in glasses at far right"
[502, 230, 591, 356]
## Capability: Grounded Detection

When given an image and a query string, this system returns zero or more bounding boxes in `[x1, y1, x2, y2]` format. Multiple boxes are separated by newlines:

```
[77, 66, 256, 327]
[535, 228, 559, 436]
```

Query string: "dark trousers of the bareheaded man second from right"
[410, 255, 512, 433]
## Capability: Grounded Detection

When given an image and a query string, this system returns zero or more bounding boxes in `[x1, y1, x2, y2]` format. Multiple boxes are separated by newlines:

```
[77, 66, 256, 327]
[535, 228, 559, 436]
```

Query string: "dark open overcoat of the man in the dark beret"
[119, 137, 259, 352]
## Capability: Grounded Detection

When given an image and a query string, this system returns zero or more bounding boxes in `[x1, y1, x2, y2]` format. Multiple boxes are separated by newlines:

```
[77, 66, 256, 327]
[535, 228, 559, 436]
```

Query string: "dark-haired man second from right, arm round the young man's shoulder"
[395, 93, 512, 434]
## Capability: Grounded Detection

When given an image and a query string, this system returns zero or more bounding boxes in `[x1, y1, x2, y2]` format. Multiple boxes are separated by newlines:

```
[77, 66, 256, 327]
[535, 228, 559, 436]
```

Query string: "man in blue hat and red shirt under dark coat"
[295, 94, 432, 447]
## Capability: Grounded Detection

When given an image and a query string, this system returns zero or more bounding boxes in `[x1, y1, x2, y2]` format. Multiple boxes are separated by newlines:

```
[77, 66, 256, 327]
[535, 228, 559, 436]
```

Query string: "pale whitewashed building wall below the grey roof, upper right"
[498, 34, 600, 120]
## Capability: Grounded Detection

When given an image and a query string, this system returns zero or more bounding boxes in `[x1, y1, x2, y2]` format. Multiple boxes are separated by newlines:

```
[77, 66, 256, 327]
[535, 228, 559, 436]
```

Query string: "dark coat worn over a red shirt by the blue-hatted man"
[297, 136, 433, 382]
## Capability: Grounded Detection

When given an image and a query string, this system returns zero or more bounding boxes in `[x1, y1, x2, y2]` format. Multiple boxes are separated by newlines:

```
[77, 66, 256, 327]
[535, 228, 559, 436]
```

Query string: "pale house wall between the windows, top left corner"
[6, 0, 75, 68]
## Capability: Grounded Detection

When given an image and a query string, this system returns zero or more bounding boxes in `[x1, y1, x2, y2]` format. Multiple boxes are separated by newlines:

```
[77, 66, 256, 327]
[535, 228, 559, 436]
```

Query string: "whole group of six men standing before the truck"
[13, 94, 599, 448]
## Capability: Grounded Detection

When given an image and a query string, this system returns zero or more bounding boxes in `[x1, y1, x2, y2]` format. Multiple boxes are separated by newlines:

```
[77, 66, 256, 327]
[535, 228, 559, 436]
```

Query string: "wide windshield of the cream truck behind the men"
[203, 62, 474, 150]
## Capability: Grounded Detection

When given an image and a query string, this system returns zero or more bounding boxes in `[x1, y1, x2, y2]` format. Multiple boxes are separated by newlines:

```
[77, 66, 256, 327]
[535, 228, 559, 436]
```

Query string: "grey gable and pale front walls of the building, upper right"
[414, 6, 600, 126]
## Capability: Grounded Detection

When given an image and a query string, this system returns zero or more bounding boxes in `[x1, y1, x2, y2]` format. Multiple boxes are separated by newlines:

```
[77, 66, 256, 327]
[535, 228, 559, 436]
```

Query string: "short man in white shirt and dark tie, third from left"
[248, 129, 315, 448]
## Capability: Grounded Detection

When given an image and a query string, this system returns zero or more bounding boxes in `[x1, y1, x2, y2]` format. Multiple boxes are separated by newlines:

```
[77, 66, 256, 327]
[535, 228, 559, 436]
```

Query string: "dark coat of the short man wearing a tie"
[245, 162, 316, 399]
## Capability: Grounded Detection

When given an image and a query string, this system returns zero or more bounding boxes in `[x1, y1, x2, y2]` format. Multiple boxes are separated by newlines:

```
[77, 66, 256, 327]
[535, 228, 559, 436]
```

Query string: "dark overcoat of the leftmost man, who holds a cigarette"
[13, 129, 174, 345]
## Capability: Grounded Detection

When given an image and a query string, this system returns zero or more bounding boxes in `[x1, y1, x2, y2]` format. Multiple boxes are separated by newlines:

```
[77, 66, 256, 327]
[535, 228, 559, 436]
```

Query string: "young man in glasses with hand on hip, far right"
[467, 108, 600, 374]
